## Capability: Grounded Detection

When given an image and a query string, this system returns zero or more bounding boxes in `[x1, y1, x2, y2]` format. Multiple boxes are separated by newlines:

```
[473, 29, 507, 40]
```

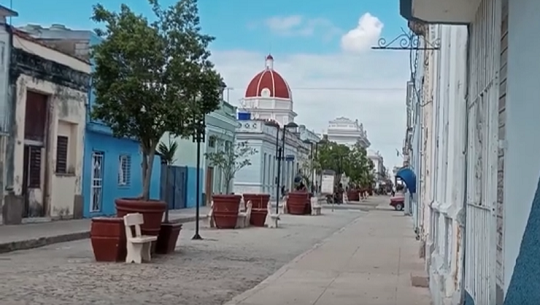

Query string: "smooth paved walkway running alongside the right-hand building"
[226, 203, 430, 305]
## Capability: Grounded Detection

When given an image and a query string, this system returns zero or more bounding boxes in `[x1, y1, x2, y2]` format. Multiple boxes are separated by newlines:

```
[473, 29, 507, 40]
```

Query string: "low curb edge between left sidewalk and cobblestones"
[0, 215, 206, 254]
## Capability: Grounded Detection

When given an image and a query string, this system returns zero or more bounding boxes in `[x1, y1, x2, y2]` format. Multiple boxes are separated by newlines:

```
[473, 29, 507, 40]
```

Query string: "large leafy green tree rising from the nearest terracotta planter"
[92, 0, 223, 200]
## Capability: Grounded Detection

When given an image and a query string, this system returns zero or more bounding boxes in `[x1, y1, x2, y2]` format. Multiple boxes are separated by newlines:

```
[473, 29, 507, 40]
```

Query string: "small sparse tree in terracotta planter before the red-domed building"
[205, 141, 257, 194]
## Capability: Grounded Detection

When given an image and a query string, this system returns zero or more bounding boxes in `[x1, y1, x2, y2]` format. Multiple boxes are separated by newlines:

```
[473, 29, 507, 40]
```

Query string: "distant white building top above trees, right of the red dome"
[327, 117, 371, 148]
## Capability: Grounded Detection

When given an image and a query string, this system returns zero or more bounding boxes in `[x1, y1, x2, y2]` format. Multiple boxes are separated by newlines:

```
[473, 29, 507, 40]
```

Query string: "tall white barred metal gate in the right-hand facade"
[464, 0, 500, 305]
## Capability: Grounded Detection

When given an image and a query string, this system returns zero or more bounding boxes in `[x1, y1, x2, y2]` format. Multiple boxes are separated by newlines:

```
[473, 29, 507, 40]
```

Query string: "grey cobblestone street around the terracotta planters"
[0, 210, 366, 305]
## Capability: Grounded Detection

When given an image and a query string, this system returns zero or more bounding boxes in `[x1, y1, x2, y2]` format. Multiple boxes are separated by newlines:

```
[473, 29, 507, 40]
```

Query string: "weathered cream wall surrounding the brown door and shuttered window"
[13, 75, 87, 218]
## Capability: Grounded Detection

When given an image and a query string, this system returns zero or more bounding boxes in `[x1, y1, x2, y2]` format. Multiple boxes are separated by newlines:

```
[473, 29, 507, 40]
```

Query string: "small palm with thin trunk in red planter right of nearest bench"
[156, 135, 182, 254]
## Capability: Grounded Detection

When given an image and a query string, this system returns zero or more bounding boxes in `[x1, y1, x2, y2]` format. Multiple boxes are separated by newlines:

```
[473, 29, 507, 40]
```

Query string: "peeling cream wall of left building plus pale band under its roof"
[13, 37, 90, 219]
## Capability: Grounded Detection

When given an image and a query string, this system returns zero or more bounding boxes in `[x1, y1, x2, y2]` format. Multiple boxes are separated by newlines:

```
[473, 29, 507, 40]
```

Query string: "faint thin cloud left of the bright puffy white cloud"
[264, 15, 341, 39]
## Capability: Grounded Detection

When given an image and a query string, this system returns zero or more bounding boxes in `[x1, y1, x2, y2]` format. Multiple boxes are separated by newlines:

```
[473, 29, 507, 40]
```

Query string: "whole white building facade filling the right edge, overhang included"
[401, 0, 540, 305]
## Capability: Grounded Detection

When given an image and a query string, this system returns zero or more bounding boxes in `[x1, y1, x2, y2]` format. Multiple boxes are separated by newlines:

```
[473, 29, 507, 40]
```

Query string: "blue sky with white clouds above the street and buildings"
[7, 0, 410, 166]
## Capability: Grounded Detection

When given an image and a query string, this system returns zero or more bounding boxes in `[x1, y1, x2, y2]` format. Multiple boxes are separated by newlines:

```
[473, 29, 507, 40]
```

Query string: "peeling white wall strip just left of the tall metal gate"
[428, 25, 467, 305]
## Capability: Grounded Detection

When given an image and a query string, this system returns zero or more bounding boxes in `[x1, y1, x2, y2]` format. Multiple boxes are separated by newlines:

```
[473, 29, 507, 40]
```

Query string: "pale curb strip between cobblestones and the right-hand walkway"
[224, 215, 363, 305]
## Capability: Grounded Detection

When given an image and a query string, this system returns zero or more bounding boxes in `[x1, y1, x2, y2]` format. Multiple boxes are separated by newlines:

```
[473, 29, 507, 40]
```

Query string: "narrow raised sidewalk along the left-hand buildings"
[0, 207, 208, 253]
